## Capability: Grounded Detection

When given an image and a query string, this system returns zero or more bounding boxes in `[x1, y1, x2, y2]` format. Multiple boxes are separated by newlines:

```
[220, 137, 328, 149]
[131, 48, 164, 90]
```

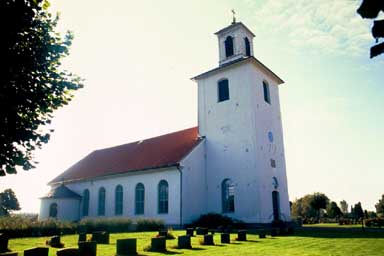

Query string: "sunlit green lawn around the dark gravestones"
[9, 229, 384, 256]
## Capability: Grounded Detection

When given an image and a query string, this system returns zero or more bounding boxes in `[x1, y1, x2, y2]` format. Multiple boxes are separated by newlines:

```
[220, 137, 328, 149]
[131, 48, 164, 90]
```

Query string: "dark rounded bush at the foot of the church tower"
[192, 213, 238, 229]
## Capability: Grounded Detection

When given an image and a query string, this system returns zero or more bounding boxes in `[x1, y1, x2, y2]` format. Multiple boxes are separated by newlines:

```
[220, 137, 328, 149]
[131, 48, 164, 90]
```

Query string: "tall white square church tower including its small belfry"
[193, 20, 290, 223]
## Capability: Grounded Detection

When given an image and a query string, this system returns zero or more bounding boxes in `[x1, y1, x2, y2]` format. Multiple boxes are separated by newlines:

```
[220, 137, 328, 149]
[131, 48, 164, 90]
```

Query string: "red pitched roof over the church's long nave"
[49, 127, 201, 184]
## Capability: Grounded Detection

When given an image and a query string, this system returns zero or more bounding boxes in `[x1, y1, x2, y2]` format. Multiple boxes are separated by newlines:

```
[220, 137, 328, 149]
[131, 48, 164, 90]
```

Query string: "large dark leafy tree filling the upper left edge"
[0, 0, 82, 176]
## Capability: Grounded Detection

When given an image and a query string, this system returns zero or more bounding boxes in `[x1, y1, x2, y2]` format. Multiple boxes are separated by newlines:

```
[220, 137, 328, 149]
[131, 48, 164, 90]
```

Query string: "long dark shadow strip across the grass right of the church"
[293, 228, 384, 239]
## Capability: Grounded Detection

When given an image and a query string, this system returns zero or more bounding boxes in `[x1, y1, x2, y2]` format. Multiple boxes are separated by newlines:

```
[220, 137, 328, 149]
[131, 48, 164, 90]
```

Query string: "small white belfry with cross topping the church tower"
[215, 21, 255, 66]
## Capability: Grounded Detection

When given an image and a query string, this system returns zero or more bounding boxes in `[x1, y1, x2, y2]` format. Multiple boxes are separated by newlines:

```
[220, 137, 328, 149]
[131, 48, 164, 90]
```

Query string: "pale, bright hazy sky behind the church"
[0, 0, 384, 212]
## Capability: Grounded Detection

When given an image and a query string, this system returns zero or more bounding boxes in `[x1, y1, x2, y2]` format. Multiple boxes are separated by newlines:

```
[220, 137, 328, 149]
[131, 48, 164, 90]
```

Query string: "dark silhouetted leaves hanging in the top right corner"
[357, 0, 384, 58]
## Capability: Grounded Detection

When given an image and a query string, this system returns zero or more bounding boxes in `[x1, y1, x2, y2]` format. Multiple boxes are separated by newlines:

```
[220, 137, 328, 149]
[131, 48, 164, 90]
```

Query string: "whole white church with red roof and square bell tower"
[39, 21, 290, 225]
